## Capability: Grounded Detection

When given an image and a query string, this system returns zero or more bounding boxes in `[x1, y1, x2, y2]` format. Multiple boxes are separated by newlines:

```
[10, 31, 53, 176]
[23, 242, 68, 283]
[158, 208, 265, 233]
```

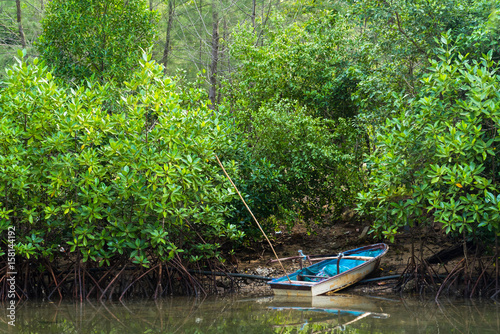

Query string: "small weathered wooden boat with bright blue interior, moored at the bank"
[267, 243, 389, 297]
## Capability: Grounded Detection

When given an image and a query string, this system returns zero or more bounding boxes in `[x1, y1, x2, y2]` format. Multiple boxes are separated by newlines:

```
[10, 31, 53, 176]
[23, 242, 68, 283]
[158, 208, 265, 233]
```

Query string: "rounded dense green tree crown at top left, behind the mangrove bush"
[37, 0, 157, 82]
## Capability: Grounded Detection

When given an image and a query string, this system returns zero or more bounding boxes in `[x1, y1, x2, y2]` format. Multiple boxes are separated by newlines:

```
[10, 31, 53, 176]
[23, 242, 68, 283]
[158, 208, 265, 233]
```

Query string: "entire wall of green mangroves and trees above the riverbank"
[0, 0, 500, 296]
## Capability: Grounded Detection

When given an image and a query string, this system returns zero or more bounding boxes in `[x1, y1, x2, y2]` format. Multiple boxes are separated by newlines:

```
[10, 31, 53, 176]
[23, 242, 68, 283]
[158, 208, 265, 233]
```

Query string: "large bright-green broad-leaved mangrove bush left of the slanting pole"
[0, 52, 243, 266]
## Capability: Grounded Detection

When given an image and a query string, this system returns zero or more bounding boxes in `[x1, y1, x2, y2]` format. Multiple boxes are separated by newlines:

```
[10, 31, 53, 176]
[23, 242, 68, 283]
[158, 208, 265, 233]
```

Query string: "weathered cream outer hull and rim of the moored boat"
[268, 244, 389, 297]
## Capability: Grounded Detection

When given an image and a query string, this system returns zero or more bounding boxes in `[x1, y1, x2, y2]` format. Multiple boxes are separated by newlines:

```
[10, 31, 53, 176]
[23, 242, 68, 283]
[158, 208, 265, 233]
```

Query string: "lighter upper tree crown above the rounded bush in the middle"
[231, 11, 362, 119]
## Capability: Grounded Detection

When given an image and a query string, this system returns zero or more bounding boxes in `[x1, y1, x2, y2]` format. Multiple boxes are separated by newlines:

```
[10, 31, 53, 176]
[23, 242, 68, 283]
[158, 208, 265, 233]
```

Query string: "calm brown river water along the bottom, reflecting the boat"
[0, 296, 500, 334]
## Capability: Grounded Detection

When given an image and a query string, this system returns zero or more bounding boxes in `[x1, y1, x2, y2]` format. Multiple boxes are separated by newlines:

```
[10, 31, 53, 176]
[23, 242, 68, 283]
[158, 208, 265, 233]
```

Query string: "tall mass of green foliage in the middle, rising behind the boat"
[225, 6, 366, 223]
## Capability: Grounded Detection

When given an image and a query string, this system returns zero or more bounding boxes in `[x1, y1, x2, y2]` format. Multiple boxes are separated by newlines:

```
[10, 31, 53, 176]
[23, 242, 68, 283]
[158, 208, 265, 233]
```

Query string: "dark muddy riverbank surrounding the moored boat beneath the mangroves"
[224, 223, 476, 296]
